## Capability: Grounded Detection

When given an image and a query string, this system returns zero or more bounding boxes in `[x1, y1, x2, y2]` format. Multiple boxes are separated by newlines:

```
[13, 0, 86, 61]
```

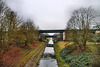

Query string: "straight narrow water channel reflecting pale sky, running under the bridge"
[39, 38, 58, 67]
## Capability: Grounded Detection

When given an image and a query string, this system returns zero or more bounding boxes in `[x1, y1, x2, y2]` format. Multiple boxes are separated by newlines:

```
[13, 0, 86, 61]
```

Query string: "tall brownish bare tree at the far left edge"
[0, 2, 19, 46]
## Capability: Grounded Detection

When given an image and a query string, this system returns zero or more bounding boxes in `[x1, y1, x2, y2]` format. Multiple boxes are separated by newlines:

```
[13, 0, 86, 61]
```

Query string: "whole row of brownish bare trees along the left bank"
[0, 0, 38, 52]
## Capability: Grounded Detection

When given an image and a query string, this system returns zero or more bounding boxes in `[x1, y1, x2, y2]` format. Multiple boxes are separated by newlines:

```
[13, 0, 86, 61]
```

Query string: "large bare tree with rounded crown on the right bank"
[66, 7, 97, 49]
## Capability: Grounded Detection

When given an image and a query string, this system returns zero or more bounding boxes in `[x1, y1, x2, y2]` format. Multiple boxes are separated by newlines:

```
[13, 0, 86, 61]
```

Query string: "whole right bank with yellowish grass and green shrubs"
[54, 41, 100, 67]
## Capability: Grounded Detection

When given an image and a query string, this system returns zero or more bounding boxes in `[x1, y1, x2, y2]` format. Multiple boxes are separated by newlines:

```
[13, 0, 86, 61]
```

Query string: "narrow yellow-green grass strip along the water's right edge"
[54, 42, 69, 67]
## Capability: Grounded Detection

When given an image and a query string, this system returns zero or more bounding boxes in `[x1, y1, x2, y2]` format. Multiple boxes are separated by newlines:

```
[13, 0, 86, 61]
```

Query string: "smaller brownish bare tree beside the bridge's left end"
[20, 19, 38, 46]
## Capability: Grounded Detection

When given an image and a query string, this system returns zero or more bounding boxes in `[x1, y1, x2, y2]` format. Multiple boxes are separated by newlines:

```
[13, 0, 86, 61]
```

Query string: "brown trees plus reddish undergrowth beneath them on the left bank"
[0, 0, 38, 67]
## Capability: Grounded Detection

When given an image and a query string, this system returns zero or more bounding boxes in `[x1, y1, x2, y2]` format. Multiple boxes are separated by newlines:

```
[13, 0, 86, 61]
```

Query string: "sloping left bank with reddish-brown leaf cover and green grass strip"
[0, 41, 45, 67]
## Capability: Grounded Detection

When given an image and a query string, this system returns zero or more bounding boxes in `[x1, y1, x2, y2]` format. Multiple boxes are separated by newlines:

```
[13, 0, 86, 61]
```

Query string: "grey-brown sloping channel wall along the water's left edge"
[24, 45, 46, 67]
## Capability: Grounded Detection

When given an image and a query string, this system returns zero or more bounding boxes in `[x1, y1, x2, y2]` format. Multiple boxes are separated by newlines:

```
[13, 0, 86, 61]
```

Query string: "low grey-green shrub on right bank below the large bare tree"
[60, 46, 95, 67]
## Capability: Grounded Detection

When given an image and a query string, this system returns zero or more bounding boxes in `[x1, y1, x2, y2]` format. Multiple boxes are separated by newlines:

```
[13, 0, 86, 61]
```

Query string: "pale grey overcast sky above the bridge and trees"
[6, 0, 100, 29]
